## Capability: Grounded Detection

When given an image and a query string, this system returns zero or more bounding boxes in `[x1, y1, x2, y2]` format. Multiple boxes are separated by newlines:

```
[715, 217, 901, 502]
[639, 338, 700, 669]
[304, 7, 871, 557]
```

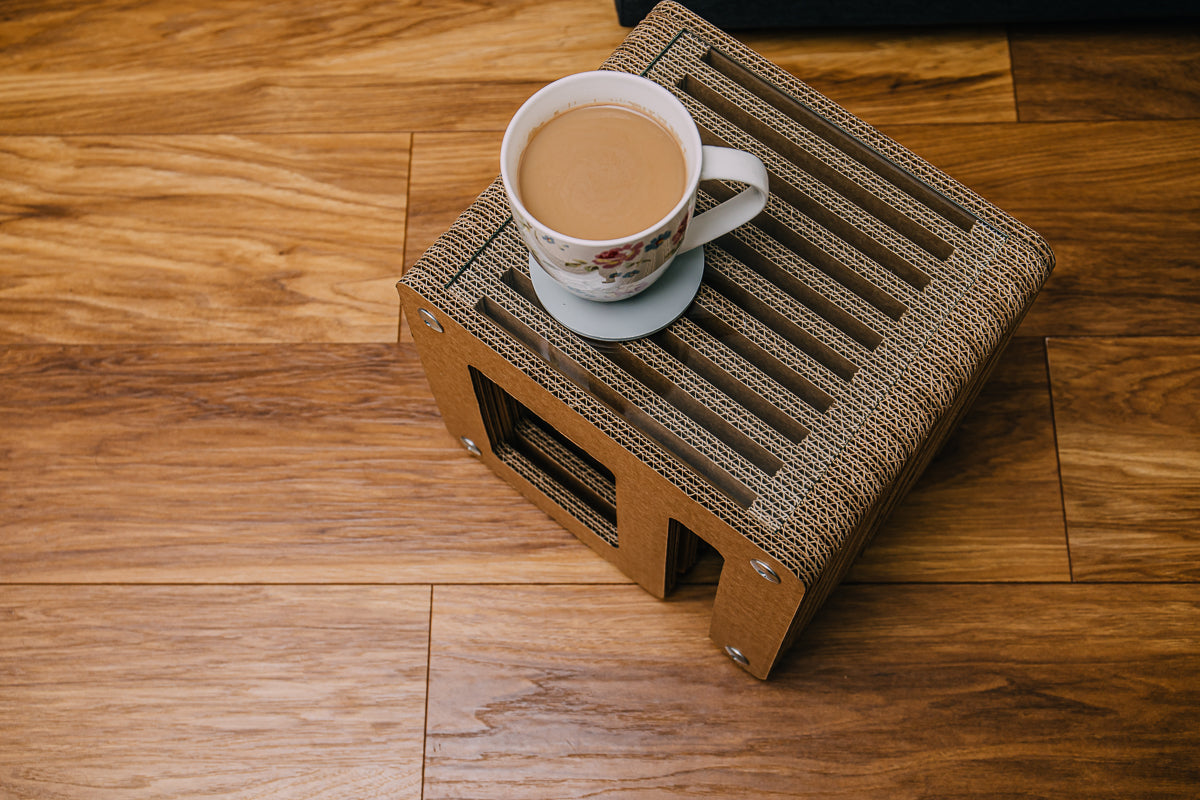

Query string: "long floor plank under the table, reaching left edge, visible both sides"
[0, 342, 1064, 583]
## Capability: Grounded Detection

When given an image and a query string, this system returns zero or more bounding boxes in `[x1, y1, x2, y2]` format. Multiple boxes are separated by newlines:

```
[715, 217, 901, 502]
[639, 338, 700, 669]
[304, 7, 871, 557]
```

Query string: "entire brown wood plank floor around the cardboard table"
[0, 0, 1200, 800]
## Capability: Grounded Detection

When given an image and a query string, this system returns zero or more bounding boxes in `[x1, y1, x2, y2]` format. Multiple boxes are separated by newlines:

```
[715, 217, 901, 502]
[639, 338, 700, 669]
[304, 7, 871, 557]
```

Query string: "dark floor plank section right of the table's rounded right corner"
[886, 120, 1200, 336]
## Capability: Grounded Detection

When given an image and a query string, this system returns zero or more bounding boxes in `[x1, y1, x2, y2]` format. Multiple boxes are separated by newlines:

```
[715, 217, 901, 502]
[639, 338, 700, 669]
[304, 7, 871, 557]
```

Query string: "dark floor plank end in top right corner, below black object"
[1009, 20, 1200, 122]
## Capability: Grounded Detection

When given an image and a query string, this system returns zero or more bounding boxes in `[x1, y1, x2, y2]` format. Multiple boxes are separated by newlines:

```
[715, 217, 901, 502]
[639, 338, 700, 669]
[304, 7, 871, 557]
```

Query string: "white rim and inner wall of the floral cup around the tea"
[500, 70, 703, 248]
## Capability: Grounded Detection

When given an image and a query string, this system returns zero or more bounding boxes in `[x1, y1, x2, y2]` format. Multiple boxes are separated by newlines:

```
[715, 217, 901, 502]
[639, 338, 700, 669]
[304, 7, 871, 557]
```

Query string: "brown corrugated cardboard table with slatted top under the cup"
[398, 2, 1052, 678]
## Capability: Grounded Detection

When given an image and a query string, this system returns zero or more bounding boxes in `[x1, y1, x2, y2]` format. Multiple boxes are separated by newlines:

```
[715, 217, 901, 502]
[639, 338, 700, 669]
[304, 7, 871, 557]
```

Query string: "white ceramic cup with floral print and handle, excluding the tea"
[500, 71, 769, 302]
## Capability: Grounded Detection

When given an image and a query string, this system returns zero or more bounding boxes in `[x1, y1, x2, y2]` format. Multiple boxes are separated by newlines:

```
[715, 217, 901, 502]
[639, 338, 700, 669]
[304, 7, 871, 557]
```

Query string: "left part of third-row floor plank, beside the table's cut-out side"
[0, 344, 628, 583]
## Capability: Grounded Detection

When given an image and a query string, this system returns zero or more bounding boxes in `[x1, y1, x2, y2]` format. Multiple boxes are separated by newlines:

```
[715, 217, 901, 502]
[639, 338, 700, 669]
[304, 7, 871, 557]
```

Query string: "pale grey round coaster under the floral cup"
[529, 247, 704, 342]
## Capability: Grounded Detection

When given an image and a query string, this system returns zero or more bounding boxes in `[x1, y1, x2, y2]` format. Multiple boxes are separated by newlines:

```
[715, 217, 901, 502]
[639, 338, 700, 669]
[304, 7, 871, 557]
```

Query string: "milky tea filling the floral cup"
[517, 103, 688, 240]
